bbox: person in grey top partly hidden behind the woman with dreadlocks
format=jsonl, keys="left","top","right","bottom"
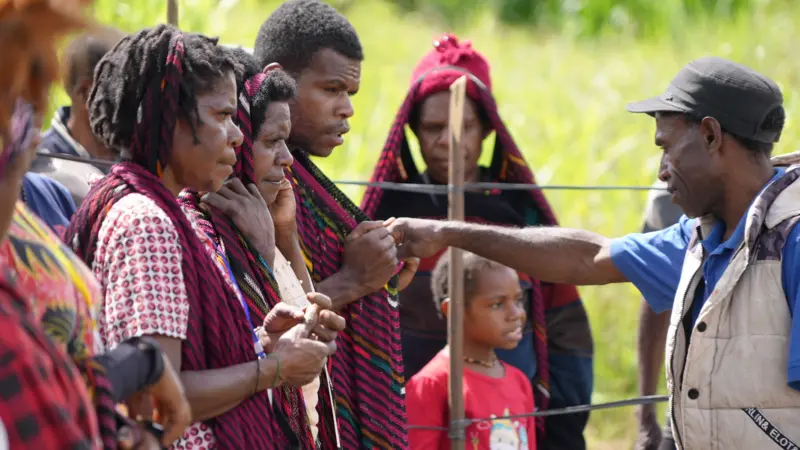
{"left": 31, "top": 26, "right": 125, "bottom": 205}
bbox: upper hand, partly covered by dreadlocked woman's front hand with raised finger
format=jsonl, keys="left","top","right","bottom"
{"left": 256, "top": 292, "right": 345, "bottom": 353}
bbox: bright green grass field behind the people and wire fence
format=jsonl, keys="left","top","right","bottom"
{"left": 58, "top": 0, "right": 800, "bottom": 450}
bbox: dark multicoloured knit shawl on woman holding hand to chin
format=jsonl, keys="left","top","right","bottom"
{"left": 180, "top": 73, "right": 336, "bottom": 450}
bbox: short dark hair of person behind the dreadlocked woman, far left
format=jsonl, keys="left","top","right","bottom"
{"left": 62, "top": 25, "right": 125, "bottom": 95}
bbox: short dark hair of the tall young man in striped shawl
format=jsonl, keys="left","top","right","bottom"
{"left": 253, "top": 0, "right": 364, "bottom": 78}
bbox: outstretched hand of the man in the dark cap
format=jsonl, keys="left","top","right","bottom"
{"left": 388, "top": 218, "right": 447, "bottom": 259}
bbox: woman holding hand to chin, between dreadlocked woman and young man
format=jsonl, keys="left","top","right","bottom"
{"left": 180, "top": 49, "right": 344, "bottom": 450}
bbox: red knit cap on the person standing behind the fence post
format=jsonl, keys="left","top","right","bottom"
{"left": 411, "top": 33, "right": 492, "bottom": 103}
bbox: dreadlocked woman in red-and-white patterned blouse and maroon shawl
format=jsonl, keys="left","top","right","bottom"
{"left": 65, "top": 25, "right": 335, "bottom": 449}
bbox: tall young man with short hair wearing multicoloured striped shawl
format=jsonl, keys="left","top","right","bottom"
{"left": 254, "top": 0, "right": 416, "bottom": 449}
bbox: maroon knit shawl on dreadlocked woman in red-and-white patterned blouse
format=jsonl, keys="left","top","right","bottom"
{"left": 65, "top": 34, "right": 286, "bottom": 450}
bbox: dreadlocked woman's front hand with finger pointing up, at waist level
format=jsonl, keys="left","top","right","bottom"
{"left": 270, "top": 304, "right": 336, "bottom": 387}
